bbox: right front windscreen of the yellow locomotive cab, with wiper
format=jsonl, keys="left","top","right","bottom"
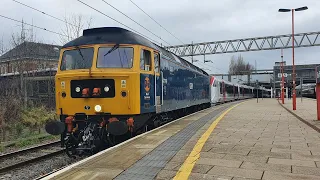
{"left": 97, "top": 46, "right": 133, "bottom": 68}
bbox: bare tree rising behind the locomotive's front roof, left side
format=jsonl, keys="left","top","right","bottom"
{"left": 60, "top": 14, "right": 92, "bottom": 44}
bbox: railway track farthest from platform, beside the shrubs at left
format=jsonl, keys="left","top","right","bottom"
{"left": 0, "top": 141, "right": 64, "bottom": 174}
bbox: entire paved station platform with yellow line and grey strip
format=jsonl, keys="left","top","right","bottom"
{"left": 45, "top": 99, "right": 320, "bottom": 180}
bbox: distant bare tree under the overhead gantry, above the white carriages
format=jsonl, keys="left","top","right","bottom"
{"left": 229, "top": 55, "right": 254, "bottom": 75}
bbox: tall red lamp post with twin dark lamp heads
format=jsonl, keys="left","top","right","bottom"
{"left": 279, "top": 6, "right": 308, "bottom": 110}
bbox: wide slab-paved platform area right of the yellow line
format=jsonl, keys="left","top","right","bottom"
{"left": 162, "top": 99, "right": 320, "bottom": 180}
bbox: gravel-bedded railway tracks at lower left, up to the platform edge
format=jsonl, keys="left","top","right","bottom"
{"left": 0, "top": 101, "right": 242, "bottom": 180}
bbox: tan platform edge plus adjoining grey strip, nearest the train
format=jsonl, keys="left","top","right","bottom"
{"left": 44, "top": 103, "right": 239, "bottom": 180}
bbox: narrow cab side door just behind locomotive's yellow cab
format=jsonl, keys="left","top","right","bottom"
{"left": 153, "top": 52, "right": 163, "bottom": 113}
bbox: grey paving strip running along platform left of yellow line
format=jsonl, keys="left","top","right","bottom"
{"left": 115, "top": 103, "right": 234, "bottom": 180}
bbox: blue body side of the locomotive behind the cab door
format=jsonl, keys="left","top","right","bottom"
{"left": 158, "top": 54, "right": 210, "bottom": 112}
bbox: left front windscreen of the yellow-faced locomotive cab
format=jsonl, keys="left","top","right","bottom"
{"left": 60, "top": 48, "right": 93, "bottom": 70}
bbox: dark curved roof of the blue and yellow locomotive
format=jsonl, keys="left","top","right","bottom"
{"left": 62, "top": 27, "right": 208, "bottom": 75}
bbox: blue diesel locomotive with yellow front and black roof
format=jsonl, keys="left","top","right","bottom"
{"left": 46, "top": 27, "right": 210, "bottom": 156}
